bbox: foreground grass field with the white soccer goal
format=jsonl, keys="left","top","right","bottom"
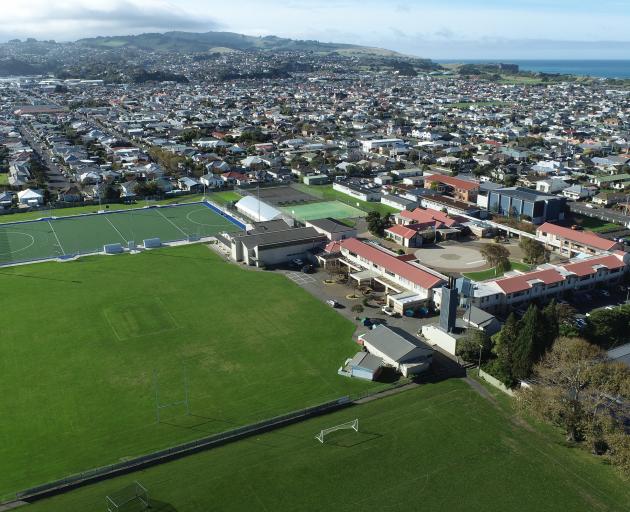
{"left": 29, "top": 380, "right": 630, "bottom": 512}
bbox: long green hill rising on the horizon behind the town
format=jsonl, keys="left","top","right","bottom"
{"left": 77, "top": 32, "right": 412, "bottom": 58}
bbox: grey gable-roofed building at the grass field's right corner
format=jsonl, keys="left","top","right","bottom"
{"left": 358, "top": 325, "right": 433, "bottom": 377}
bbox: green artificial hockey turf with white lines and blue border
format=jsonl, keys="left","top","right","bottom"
{"left": 0, "top": 203, "right": 243, "bottom": 265}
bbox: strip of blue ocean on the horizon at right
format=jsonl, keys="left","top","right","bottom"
{"left": 438, "top": 59, "right": 630, "bottom": 78}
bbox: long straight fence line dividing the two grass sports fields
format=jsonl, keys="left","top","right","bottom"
{"left": 11, "top": 379, "right": 409, "bottom": 505}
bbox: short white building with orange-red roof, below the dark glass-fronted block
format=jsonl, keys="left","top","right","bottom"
{"left": 536, "top": 222, "right": 620, "bottom": 258}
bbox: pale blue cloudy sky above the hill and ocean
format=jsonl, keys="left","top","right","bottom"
{"left": 0, "top": 0, "right": 630, "bottom": 60}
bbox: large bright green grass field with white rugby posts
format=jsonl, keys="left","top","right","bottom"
{"left": 0, "top": 245, "right": 379, "bottom": 498}
